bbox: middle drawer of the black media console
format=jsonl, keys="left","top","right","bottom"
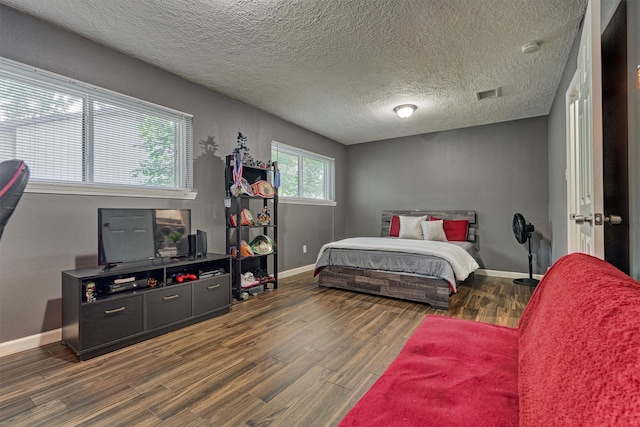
{"left": 145, "top": 284, "right": 191, "bottom": 329}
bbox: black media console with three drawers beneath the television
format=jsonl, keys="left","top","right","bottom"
{"left": 62, "top": 253, "right": 231, "bottom": 360}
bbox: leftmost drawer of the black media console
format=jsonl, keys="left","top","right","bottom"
{"left": 80, "top": 295, "right": 143, "bottom": 349}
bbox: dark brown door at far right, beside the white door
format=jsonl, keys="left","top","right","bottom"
{"left": 602, "top": 0, "right": 631, "bottom": 274}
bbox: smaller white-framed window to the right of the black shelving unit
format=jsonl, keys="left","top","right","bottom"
{"left": 271, "top": 141, "right": 334, "bottom": 203}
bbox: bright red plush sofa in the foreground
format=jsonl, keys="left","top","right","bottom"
{"left": 340, "top": 254, "right": 640, "bottom": 427}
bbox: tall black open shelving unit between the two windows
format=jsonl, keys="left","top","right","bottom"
{"left": 225, "top": 155, "right": 278, "bottom": 300}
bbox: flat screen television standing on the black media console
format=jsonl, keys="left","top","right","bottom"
{"left": 98, "top": 208, "right": 191, "bottom": 265}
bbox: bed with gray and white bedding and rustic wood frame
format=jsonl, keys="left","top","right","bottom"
{"left": 314, "top": 210, "right": 479, "bottom": 310}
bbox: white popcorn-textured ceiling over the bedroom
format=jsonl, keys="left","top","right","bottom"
{"left": 0, "top": 0, "right": 587, "bottom": 144}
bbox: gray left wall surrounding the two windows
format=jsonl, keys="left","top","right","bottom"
{"left": 0, "top": 6, "right": 346, "bottom": 342}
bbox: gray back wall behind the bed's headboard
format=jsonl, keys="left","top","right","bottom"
{"left": 347, "top": 117, "right": 550, "bottom": 273}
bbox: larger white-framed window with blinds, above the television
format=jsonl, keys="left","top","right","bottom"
{"left": 0, "top": 59, "right": 193, "bottom": 197}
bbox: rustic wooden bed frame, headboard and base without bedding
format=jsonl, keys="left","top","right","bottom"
{"left": 318, "top": 210, "right": 476, "bottom": 310}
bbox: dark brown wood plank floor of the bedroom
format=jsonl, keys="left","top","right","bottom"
{"left": 0, "top": 273, "right": 533, "bottom": 426}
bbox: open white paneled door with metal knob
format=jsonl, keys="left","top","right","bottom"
{"left": 567, "top": 0, "right": 604, "bottom": 259}
